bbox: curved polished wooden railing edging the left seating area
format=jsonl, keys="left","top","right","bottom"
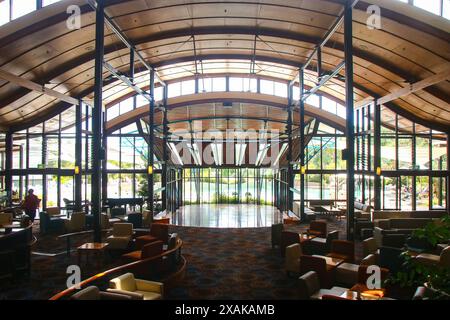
{"left": 49, "top": 239, "right": 187, "bottom": 300}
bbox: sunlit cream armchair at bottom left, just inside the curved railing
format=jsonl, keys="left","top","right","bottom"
{"left": 108, "top": 273, "right": 164, "bottom": 300}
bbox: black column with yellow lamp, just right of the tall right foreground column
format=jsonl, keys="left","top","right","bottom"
{"left": 373, "top": 100, "right": 381, "bottom": 210}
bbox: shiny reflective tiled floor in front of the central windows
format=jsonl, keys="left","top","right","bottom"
{"left": 171, "top": 204, "right": 282, "bottom": 228}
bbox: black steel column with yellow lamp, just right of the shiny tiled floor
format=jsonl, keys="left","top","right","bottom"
{"left": 299, "top": 68, "right": 306, "bottom": 221}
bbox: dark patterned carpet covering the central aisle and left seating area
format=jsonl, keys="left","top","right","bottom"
{"left": 0, "top": 220, "right": 361, "bottom": 300}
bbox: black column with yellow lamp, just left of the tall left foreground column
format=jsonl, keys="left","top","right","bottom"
{"left": 74, "top": 99, "right": 82, "bottom": 212}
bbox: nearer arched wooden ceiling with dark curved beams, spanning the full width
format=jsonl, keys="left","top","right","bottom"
{"left": 0, "top": 0, "right": 450, "bottom": 131}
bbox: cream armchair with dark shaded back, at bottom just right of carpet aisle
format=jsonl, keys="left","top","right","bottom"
{"left": 298, "top": 271, "right": 347, "bottom": 300}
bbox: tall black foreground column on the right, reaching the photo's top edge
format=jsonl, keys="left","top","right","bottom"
{"left": 344, "top": 0, "right": 355, "bottom": 240}
